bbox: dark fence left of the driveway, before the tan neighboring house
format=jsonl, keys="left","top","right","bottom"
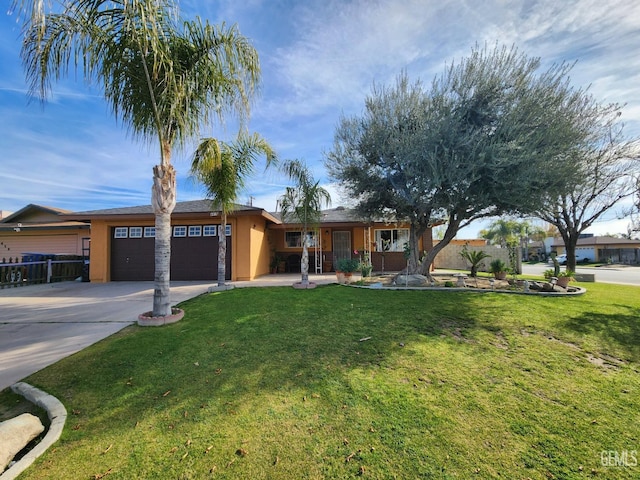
{"left": 0, "top": 255, "right": 88, "bottom": 288}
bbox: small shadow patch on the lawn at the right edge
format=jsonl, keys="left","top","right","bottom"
{"left": 561, "top": 305, "right": 640, "bottom": 362}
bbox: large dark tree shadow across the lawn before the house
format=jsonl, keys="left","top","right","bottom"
{"left": 26, "top": 286, "right": 484, "bottom": 432}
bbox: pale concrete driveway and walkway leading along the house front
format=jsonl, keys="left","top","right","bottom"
{"left": 0, "top": 274, "right": 335, "bottom": 390}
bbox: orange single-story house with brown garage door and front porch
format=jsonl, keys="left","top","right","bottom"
{"left": 66, "top": 200, "right": 432, "bottom": 282}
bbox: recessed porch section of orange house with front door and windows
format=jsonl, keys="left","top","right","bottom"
{"left": 270, "top": 207, "right": 433, "bottom": 273}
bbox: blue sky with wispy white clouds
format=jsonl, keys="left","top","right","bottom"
{"left": 0, "top": 0, "right": 640, "bottom": 238}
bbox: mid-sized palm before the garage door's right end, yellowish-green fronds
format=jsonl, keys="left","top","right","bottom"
{"left": 191, "top": 131, "right": 276, "bottom": 287}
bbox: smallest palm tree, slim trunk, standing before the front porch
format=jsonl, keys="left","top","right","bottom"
{"left": 279, "top": 160, "right": 331, "bottom": 287}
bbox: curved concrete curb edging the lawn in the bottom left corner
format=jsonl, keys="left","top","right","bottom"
{"left": 0, "top": 382, "right": 67, "bottom": 480}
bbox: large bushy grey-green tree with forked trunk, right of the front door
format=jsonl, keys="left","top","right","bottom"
{"left": 325, "top": 46, "right": 593, "bottom": 274}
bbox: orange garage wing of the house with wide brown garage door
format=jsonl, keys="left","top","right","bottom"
{"left": 67, "top": 200, "right": 279, "bottom": 282}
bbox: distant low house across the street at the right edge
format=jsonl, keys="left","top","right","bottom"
{"left": 552, "top": 236, "right": 640, "bottom": 264}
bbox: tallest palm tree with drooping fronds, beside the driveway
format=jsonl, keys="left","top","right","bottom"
{"left": 21, "top": 0, "right": 260, "bottom": 316}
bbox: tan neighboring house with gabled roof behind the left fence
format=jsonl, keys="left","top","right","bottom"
{"left": 0, "top": 204, "right": 90, "bottom": 261}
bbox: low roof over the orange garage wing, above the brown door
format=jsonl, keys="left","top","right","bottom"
{"left": 65, "top": 199, "right": 280, "bottom": 223}
